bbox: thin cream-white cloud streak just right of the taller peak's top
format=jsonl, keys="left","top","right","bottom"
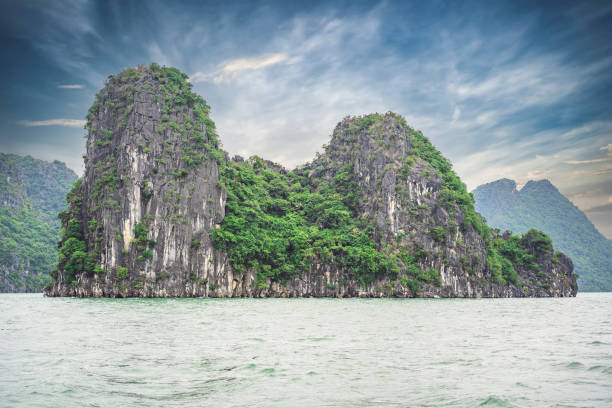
{"left": 190, "top": 52, "right": 292, "bottom": 83}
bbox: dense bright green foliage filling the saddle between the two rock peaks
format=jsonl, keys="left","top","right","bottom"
{"left": 212, "top": 157, "right": 397, "bottom": 286}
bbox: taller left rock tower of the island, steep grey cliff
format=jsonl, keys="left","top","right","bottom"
{"left": 47, "top": 64, "right": 231, "bottom": 296}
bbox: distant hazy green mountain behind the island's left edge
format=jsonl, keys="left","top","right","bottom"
{"left": 0, "top": 153, "right": 77, "bottom": 292}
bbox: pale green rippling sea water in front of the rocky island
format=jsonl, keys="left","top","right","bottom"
{"left": 0, "top": 293, "right": 612, "bottom": 407}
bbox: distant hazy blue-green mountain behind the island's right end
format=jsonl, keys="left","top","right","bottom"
{"left": 472, "top": 179, "right": 612, "bottom": 291}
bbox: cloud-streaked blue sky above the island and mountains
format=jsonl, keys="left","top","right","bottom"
{"left": 0, "top": 0, "right": 612, "bottom": 237}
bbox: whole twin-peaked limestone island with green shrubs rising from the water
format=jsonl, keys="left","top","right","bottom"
{"left": 46, "top": 65, "right": 577, "bottom": 297}
